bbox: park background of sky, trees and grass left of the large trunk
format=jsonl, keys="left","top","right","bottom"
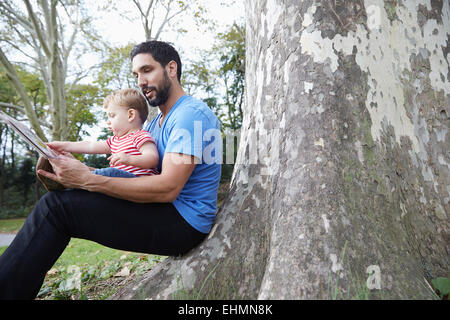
{"left": 0, "top": 0, "right": 245, "bottom": 299}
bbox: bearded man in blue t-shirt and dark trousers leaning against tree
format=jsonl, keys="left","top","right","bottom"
{"left": 0, "top": 41, "right": 221, "bottom": 299}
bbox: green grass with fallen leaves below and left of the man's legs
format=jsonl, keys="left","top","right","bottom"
{"left": 0, "top": 219, "right": 165, "bottom": 300}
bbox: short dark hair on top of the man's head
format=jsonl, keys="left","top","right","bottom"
{"left": 130, "top": 40, "right": 181, "bottom": 83}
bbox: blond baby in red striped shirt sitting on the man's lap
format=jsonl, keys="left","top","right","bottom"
{"left": 47, "top": 89, "right": 159, "bottom": 178}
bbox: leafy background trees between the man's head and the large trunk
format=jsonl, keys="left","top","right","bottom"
{"left": 182, "top": 23, "right": 245, "bottom": 182}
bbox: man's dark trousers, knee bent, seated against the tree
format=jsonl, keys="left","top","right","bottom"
{"left": 0, "top": 189, "right": 206, "bottom": 299}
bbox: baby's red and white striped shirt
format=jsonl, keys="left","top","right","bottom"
{"left": 106, "top": 129, "right": 158, "bottom": 176}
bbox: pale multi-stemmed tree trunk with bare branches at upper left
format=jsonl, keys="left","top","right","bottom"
{"left": 0, "top": 0, "right": 79, "bottom": 141}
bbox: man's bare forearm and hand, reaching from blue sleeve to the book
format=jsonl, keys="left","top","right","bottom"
{"left": 39, "top": 152, "right": 195, "bottom": 203}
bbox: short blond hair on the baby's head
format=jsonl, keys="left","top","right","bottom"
{"left": 103, "top": 89, "right": 148, "bottom": 123}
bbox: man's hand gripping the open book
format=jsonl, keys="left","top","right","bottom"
{"left": 38, "top": 152, "right": 92, "bottom": 188}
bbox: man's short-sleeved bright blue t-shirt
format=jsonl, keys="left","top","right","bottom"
{"left": 145, "top": 95, "right": 222, "bottom": 233}
